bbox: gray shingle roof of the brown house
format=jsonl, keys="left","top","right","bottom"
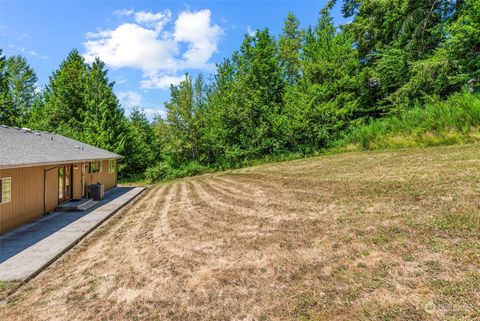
{"left": 0, "top": 125, "right": 122, "bottom": 169}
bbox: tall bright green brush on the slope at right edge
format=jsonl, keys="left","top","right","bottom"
{"left": 337, "top": 91, "right": 480, "bottom": 149}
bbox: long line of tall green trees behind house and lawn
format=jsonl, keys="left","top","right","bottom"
{"left": 0, "top": 0, "right": 480, "bottom": 179}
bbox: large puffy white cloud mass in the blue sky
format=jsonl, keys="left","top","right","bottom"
{"left": 84, "top": 9, "right": 223, "bottom": 89}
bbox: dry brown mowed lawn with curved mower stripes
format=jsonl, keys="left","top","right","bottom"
{"left": 0, "top": 145, "right": 480, "bottom": 321}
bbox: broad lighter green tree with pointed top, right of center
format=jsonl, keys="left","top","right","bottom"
{"left": 285, "top": 10, "right": 363, "bottom": 152}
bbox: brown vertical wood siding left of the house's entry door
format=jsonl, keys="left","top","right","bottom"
{"left": 0, "top": 166, "right": 58, "bottom": 233}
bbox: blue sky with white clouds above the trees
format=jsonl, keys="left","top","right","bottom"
{"left": 0, "top": 1, "right": 346, "bottom": 117}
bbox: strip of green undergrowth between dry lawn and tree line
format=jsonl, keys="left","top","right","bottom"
{"left": 138, "top": 91, "right": 480, "bottom": 184}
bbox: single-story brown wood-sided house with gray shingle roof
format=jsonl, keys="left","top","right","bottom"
{"left": 0, "top": 125, "right": 122, "bottom": 233}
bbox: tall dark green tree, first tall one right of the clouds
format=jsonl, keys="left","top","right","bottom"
{"left": 228, "top": 29, "right": 285, "bottom": 157}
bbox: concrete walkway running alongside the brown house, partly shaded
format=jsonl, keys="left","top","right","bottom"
{"left": 0, "top": 187, "right": 144, "bottom": 281}
